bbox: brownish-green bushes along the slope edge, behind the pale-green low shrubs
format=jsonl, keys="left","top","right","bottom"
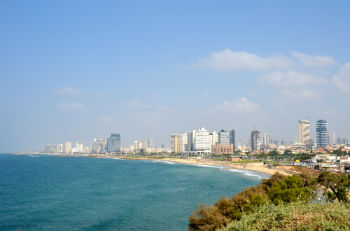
{"left": 188, "top": 174, "right": 312, "bottom": 231}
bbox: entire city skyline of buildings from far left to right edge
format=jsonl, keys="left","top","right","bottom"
{"left": 44, "top": 120, "right": 348, "bottom": 156}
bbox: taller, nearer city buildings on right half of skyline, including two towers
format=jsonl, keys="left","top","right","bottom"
{"left": 170, "top": 120, "right": 348, "bottom": 155}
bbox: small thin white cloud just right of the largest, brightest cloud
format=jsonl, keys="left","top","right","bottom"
{"left": 292, "top": 51, "right": 337, "bottom": 68}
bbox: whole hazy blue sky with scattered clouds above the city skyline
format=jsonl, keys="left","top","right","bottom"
{"left": 0, "top": 0, "right": 350, "bottom": 152}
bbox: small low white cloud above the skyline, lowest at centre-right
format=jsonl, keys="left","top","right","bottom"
{"left": 216, "top": 97, "right": 262, "bottom": 114}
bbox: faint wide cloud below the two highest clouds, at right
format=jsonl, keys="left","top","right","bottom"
{"left": 259, "top": 70, "right": 327, "bottom": 88}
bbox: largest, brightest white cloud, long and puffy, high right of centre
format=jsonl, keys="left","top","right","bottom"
{"left": 193, "top": 49, "right": 293, "bottom": 71}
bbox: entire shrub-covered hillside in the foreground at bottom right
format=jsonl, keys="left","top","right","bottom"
{"left": 188, "top": 172, "right": 350, "bottom": 231}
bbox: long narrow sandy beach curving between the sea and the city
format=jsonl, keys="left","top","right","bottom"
{"left": 12, "top": 153, "right": 293, "bottom": 176}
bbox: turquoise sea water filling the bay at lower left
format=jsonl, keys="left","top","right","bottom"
{"left": 0, "top": 154, "right": 261, "bottom": 230}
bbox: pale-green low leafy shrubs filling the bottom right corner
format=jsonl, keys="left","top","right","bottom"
{"left": 220, "top": 202, "right": 350, "bottom": 231}
